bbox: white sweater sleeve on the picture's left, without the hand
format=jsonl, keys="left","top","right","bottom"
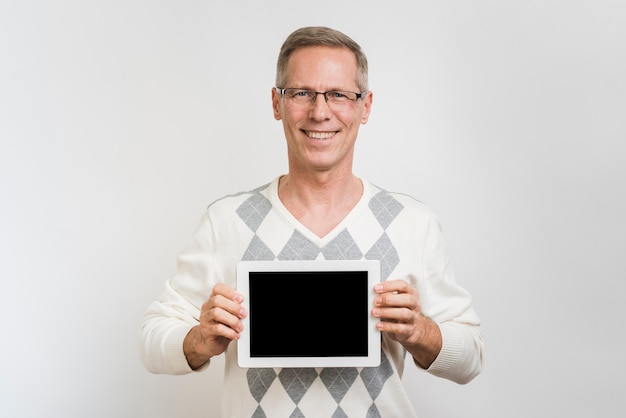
{"left": 140, "top": 214, "right": 215, "bottom": 374}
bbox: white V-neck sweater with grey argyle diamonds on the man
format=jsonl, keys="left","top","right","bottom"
{"left": 141, "top": 178, "right": 483, "bottom": 418}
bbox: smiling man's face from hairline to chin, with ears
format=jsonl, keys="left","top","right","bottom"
{"left": 272, "top": 46, "right": 372, "bottom": 172}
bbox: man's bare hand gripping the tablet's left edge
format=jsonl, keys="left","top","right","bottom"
{"left": 183, "top": 283, "right": 247, "bottom": 369}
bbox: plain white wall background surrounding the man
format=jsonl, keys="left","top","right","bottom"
{"left": 0, "top": 0, "right": 626, "bottom": 417}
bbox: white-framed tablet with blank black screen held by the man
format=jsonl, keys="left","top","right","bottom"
{"left": 237, "top": 260, "right": 381, "bottom": 368}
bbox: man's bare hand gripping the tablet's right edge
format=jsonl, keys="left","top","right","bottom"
{"left": 372, "top": 280, "right": 442, "bottom": 369}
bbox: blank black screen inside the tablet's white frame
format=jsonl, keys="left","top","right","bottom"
{"left": 249, "top": 271, "right": 371, "bottom": 357}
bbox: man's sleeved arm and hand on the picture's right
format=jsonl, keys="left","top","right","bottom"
{"left": 372, "top": 214, "right": 483, "bottom": 383}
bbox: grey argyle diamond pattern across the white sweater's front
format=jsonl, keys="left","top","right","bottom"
{"left": 237, "top": 187, "right": 404, "bottom": 418}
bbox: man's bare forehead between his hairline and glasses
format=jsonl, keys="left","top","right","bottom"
{"left": 287, "top": 46, "right": 358, "bottom": 90}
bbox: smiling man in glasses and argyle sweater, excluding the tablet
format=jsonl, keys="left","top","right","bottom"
{"left": 142, "top": 27, "right": 483, "bottom": 418}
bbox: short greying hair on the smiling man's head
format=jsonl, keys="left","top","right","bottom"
{"left": 276, "top": 26, "right": 368, "bottom": 92}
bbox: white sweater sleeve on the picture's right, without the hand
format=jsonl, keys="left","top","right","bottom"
{"left": 418, "top": 213, "right": 483, "bottom": 384}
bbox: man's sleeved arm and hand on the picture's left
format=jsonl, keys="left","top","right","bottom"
{"left": 140, "top": 212, "right": 246, "bottom": 374}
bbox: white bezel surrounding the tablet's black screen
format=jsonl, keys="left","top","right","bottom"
{"left": 237, "top": 260, "right": 381, "bottom": 368}
